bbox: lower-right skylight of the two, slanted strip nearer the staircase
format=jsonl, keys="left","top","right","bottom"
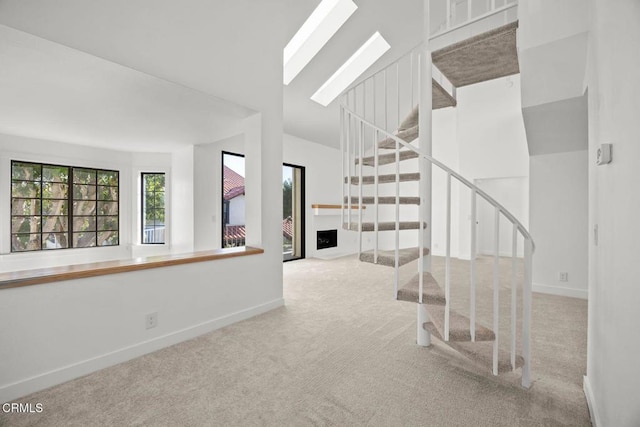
{"left": 311, "top": 31, "right": 391, "bottom": 107}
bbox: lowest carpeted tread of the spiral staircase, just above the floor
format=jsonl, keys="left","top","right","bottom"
{"left": 425, "top": 323, "right": 524, "bottom": 374}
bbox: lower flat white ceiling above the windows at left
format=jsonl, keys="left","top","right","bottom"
{"left": 0, "top": 25, "right": 250, "bottom": 152}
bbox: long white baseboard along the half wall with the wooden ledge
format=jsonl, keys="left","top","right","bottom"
{"left": 0, "top": 298, "right": 284, "bottom": 402}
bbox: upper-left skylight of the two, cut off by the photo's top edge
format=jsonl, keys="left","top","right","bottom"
{"left": 283, "top": 0, "right": 358, "bottom": 85}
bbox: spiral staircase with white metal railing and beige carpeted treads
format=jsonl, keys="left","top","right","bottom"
{"left": 340, "top": 19, "right": 534, "bottom": 387}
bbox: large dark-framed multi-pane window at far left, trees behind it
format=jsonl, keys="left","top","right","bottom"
{"left": 11, "top": 161, "right": 119, "bottom": 252}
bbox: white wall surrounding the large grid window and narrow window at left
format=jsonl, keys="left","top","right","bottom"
{"left": 0, "top": 134, "right": 193, "bottom": 271}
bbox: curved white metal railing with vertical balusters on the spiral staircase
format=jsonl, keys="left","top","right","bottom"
{"left": 340, "top": 42, "right": 535, "bottom": 387}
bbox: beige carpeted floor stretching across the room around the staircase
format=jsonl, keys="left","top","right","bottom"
{"left": 0, "top": 256, "right": 590, "bottom": 427}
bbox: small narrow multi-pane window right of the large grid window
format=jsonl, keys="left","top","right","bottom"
{"left": 142, "top": 173, "right": 165, "bottom": 244}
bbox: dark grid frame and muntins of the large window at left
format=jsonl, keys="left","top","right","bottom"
{"left": 9, "top": 159, "right": 121, "bottom": 254}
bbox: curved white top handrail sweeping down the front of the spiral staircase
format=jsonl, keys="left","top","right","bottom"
{"left": 340, "top": 106, "right": 536, "bottom": 253}
